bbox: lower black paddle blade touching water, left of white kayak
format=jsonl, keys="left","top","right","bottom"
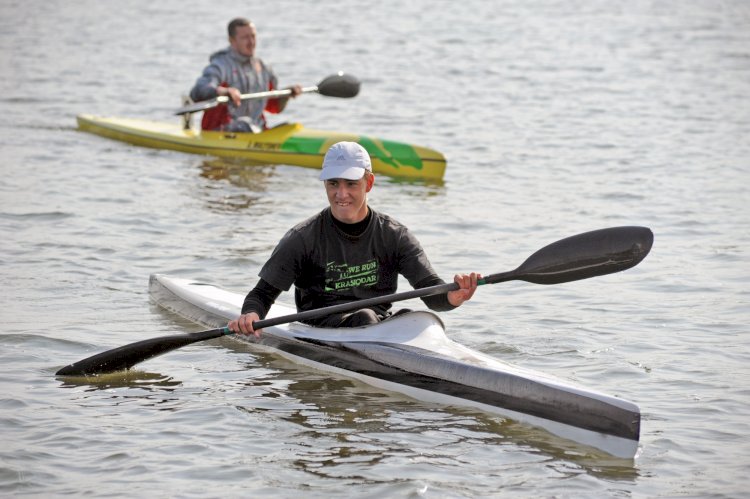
{"left": 55, "top": 328, "right": 229, "bottom": 376}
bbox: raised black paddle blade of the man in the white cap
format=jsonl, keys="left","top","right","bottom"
{"left": 485, "top": 227, "right": 654, "bottom": 284}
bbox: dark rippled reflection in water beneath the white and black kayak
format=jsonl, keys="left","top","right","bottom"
{"left": 231, "top": 356, "right": 639, "bottom": 481}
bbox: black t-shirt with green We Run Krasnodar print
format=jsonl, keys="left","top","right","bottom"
{"left": 259, "top": 208, "right": 444, "bottom": 314}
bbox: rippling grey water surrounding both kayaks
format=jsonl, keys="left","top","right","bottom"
{"left": 0, "top": 0, "right": 750, "bottom": 498}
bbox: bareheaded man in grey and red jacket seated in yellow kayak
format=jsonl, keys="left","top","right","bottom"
{"left": 190, "top": 18, "right": 302, "bottom": 132}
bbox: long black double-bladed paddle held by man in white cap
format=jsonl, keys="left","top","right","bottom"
{"left": 56, "top": 227, "right": 654, "bottom": 376}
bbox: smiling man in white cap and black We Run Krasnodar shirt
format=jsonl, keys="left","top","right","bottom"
{"left": 229, "top": 142, "right": 481, "bottom": 336}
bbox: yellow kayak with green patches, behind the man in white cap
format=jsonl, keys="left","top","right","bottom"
{"left": 77, "top": 114, "right": 446, "bottom": 180}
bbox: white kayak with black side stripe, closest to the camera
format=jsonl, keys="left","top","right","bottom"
{"left": 149, "top": 274, "right": 640, "bottom": 459}
